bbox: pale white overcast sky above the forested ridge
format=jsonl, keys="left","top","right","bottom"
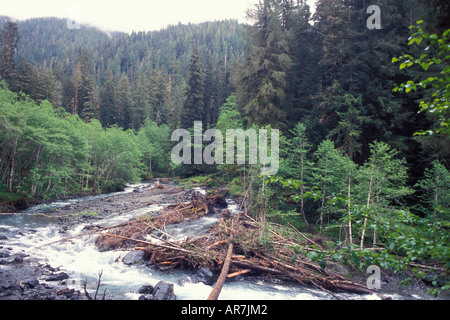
{"left": 0, "top": 0, "right": 314, "bottom": 32}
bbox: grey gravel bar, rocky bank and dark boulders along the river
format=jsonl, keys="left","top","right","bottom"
{"left": 0, "top": 181, "right": 442, "bottom": 300}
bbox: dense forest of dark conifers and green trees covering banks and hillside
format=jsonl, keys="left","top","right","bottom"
{"left": 0, "top": 0, "right": 450, "bottom": 292}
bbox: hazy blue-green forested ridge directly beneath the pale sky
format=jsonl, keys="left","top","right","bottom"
{"left": 0, "top": 16, "right": 245, "bottom": 78}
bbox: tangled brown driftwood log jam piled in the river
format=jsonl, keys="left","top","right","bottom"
{"left": 96, "top": 194, "right": 384, "bottom": 299}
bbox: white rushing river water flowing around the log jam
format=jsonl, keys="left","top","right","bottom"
{"left": 0, "top": 185, "right": 408, "bottom": 300}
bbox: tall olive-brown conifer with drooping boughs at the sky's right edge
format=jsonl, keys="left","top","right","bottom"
{"left": 235, "top": 0, "right": 292, "bottom": 127}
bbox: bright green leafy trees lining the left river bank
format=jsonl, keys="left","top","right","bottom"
{"left": 0, "top": 83, "right": 142, "bottom": 199}
